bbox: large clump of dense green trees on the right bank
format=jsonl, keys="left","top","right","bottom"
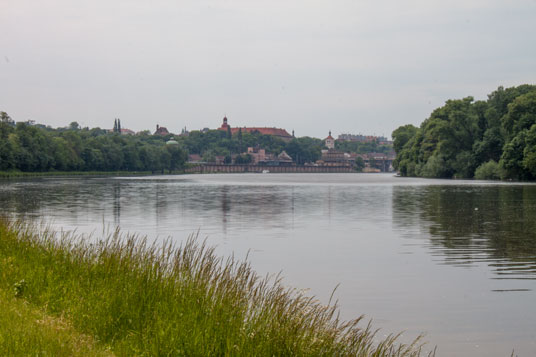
{"left": 392, "top": 84, "right": 536, "bottom": 180}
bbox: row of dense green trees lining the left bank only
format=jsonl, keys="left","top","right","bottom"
{"left": 0, "top": 113, "right": 186, "bottom": 172}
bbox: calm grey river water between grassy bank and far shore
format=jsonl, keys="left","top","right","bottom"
{"left": 0, "top": 174, "right": 536, "bottom": 356}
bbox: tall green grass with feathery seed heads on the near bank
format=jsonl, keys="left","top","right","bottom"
{"left": 0, "top": 221, "right": 430, "bottom": 356}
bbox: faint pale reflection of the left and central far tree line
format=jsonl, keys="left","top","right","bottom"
{"left": 0, "top": 178, "right": 382, "bottom": 236}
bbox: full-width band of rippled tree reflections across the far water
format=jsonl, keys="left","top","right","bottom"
{"left": 4, "top": 176, "right": 536, "bottom": 279}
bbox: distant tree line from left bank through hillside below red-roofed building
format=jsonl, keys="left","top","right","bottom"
{"left": 0, "top": 112, "right": 391, "bottom": 172}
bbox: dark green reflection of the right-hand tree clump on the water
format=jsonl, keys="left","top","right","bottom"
{"left": 393, "top": 185, "right": 536, "bottom": 279}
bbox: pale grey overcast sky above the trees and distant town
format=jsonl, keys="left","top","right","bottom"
{"left": 0, "top": 0, "right": 536, "bottom": 137}
